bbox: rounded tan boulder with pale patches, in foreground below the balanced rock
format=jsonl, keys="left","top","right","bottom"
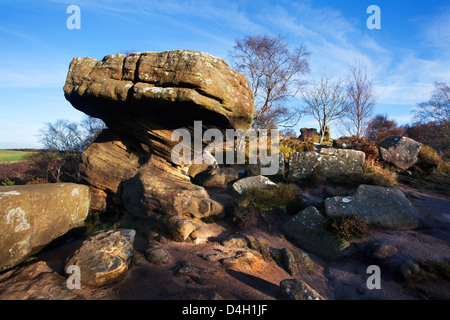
{"left": 65, "top": 229, "right": 136, "bottom": 287}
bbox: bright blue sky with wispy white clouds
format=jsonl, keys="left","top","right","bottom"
{"left": 0, "top": 0, "right": 450, "bottom": 148}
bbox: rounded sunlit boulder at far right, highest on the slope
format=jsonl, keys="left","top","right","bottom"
{"left": 378, "top": 136, "right": 422, "bottom": 170}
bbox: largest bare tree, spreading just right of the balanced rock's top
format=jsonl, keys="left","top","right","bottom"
{"left": 230, "top": 35, "right": 309, "bottom": 128}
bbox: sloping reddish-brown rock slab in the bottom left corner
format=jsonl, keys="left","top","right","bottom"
{"left": 0, "top": 261, "right": 77, "bottom": 300}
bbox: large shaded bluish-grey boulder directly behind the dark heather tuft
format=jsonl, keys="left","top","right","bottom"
{"left": 325, "top": 185, "right": 420, "bottom": 230}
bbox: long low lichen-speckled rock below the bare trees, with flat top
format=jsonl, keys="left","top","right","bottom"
{"left": 287, "top": 148, "right": 365, "bottom": 181}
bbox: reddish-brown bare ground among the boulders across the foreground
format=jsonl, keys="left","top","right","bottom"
{"left": 0, "top": 178, "right": 450, "bottom": 300}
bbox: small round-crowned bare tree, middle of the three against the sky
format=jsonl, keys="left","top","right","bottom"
{"left": 303, "top": 74, "right": 350, "bottom": 143}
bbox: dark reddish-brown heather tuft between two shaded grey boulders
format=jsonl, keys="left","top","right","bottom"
{"left": 322, "top": 215, "right": 368, "bottom": 241}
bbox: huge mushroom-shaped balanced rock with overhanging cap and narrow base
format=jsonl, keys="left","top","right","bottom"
{"left": 64, "top": 50, "right": 254, "bottom": 239}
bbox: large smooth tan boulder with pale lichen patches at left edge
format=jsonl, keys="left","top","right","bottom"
{"left": 0, "top": 183, "right": 90, "bottom": 271}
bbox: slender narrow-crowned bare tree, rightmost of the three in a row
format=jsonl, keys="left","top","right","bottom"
{"left": 342, "top": 61, "right": 378, "bottom": 139}
